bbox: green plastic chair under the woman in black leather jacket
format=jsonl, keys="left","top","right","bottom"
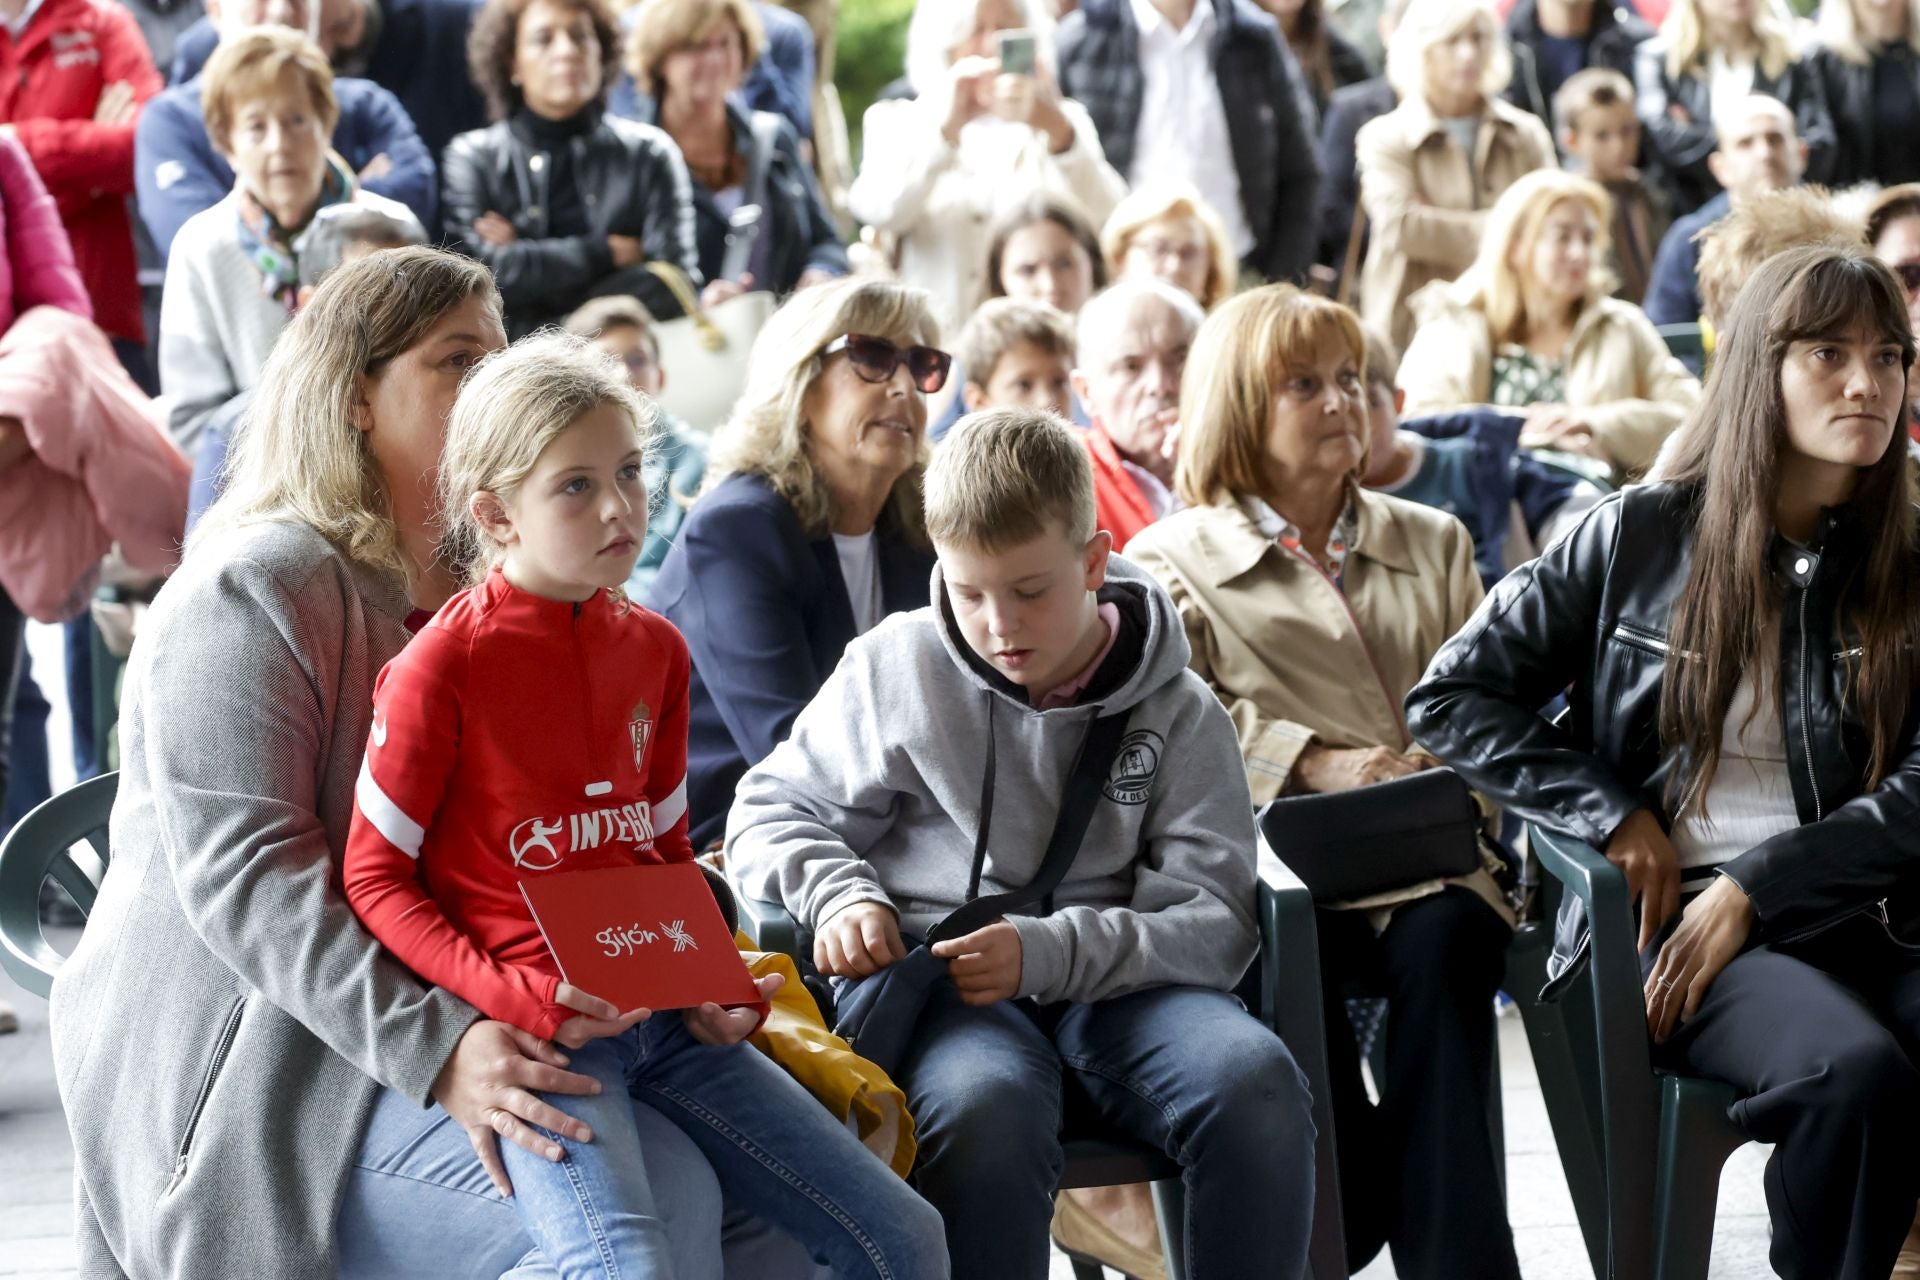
{"left": 1517, "top": 825, "right": 1747, "bottom": 1280}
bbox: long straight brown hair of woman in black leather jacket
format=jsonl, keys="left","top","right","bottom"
{"left": 1661, "top": 246, "right": 1920, "bottom": 816}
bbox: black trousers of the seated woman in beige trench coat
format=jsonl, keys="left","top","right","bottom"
{"left": 1315, "top": 887, "right": 1520, "bottom": 1280}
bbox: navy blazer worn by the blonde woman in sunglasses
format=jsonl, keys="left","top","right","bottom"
{"left": 653, "top": 474, "right": 933, "bottom": 850}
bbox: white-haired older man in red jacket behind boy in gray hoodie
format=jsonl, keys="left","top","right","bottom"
{"left": 1073, "top": 280, "right": 1206, "bottom": 551}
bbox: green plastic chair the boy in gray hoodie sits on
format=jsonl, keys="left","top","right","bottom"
{"left": 739, "top": 858, "right": 1346, "bottom": 1280}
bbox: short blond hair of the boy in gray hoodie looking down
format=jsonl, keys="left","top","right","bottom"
{"left": 925, "top": 409, "right": 1096, "bottom": 555}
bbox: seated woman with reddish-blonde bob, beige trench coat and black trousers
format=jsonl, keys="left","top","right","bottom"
{"left": 1127, "top": 284, "right": 1519, "bottom": 1280}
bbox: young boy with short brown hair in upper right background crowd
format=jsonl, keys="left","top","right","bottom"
{"left": 1553, "top": 67, "right": 1670, "bottom": 305}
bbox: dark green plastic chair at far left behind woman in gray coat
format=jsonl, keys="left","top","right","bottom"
{"left": 0, "top": 773, "right": 119, "bottom": 998}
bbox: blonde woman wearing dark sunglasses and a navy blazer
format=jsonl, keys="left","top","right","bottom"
{"left": 653, "top": 278, "right": 952, "bottom": 848}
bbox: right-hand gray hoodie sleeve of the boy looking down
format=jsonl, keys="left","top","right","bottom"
{"left": 1012, "top": 687, "right": 1260, "bottom": 1004}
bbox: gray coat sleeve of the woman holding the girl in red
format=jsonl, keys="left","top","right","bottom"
{"left": 142, "top": 560, "right": 478, "bottom": 1105}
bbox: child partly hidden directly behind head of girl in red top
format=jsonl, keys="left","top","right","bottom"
{"left": 566, "top": 296, "right": 707, "bottom": 604}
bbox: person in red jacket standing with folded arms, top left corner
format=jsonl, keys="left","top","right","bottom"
{"left": 0, "top": 0, "right": 161, "bottom": 383}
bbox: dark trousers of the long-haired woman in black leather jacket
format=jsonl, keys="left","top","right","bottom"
{"left": 1642, "top": 917, "right": 1920, "bottom": 1280}
